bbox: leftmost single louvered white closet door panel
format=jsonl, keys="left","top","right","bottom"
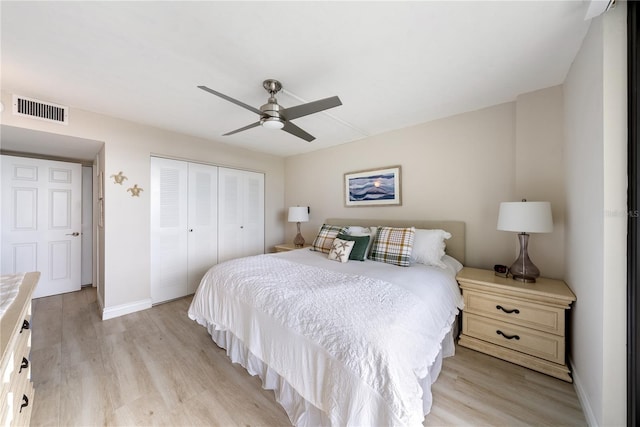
{"left": 150, "top": 157, "right": 189, "bottom": 304}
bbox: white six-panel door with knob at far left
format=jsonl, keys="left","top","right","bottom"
{"left": 1, "top": 156, "right": 82, "bottom": 298}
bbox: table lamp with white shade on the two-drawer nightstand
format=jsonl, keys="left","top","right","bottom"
{"left": 497, "top": 199, "right": 553, "bottom": 283}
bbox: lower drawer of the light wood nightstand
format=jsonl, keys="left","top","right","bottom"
{"left": 462, "top": 312, "right": 565, "bottom": 364}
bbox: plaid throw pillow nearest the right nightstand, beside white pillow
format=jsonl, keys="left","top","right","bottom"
{"left": 369, "top": 227, "right": 416, "bottom": 267}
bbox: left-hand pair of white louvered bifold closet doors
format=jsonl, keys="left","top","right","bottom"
{"left": 151, "top": 157, "right": 218, "bottom": 304}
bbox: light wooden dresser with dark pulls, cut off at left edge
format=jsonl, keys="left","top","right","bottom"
{"left": 0, "top": 272, "right": 40, "bottom": 426}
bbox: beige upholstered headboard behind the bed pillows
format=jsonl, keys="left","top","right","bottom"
{"left": 325, "top": 218, "right": 465, "bottom": 264}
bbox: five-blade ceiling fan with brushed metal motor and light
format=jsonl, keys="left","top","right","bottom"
{"left": 198, "top": 79, "right": 342, "bottom": 142}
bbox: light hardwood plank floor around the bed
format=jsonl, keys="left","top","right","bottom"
{"left": 31, "top": 288, "right": 586, "bottom": 426}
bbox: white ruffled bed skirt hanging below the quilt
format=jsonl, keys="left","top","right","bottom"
{"left": 207, "top": 322, "right": 457, "bottom": 426}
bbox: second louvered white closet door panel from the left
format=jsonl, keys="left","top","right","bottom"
{"left": 187, "top": 163, "right": 218, "bottom": 294}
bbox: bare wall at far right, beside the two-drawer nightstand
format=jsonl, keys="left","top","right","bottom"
{"left": 564, "top": 2, "right": 627, "bottom": 426}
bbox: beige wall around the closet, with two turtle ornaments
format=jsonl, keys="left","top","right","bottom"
{"left": 2, "top": 92, "right": 284, "bottom": 317}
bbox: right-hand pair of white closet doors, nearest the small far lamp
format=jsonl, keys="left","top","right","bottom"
{"left": 218, "top": 168, "right": 264, "bottom": 262}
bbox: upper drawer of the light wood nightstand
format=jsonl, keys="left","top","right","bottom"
{"left": 464, "top": 290, "right": 565, "bottom": 336}
